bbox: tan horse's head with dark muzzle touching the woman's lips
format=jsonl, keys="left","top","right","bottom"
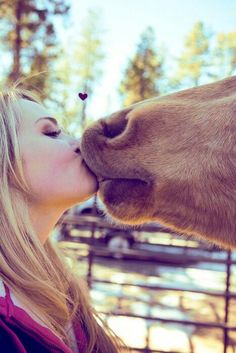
{"left": 81, "top": 76, "right": 236, "bottom": 248}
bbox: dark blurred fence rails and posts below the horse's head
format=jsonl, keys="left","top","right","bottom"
{"left": 58, "top": 215, "right": 236, "bottom": 353}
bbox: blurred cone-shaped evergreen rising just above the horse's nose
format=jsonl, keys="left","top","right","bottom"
{"left": 119, "top": 27, "right": 164, "bottom": 106}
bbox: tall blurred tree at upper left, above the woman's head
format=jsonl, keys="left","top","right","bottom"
{"left": 0, "top": 0, "right": 69, "bottom": 98}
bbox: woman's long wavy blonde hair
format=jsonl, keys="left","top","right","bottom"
{"left": 0, "top": 84, "right": 127, "bottom": 353}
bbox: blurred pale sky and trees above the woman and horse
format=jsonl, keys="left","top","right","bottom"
{"left": 0, "top": 0, "right": 236, "bottom": 135}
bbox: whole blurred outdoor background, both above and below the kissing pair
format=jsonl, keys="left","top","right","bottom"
{"left": 0, "top": 0, "right": 236, "bottom": 353}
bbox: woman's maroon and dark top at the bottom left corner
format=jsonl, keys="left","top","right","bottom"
{"left": 0, "top": 282, "right": 86, "bottom": 353}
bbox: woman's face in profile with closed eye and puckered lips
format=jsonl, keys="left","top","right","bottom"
{"left": 16, "top": 99, "right": 98, "bottom": 210}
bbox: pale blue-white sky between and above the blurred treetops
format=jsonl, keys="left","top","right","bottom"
{"left": 55, "top": 0, "right": 236, "bottom": 119}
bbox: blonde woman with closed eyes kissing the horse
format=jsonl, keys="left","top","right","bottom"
{"left": 0, "top": 85, "right": 125, "bottom": 353}
